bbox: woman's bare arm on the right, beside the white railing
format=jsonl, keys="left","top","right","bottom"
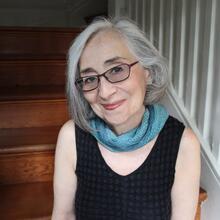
{"left": 171, "top": 129, "right": 200, "bottom": 220}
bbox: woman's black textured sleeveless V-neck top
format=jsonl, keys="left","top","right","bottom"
{"left": 75, "top": 116, "right": 184, "bottom": 220}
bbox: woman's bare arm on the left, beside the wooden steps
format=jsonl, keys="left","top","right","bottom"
{"left": 52, "top": 121, "right": 77, "bottom": 220}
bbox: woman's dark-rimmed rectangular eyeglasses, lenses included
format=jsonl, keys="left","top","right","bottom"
{"left": 75, "top": 61, "right": 138, "bottom": 92}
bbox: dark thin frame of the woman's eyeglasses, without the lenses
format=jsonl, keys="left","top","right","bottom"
{"left": 75, "top": 61, "right": 139, "bottom": 92}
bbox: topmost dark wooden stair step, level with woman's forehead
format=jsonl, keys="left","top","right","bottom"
{"left": 0, "top": 27, "right": 81, "bottom": 60}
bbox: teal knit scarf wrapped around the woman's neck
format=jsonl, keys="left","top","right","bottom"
{"left": 90, "top": 104, "right": 168, "bottom": 152}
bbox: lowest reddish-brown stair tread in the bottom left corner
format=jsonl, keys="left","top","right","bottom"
{"left": 0, "top": 182, "right": 53, "bottom": 220}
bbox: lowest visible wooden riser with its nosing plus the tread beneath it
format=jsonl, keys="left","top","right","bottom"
{"left": 0, "top": 144, "right": 55, "bottom": 220}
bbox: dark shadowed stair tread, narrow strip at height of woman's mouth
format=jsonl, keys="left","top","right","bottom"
{"left": 0, "top": 85, "right": 65, "bottom": 101}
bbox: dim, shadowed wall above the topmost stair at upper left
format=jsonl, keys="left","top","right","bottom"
{"left": 0, "top": 0, "right": 108, "bottom": 27}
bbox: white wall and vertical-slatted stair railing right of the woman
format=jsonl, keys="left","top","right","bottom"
{"left": 109, "top": 0, "right": 220, "bottom": 220}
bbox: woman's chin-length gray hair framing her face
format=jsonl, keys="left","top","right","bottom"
{"left": 66, "top": 18, "right": 168, "bottom": 131}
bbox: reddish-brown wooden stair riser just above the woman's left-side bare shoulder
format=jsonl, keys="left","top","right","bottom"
{"left": 0, "top": 99, "right": 68, "bottom": 129}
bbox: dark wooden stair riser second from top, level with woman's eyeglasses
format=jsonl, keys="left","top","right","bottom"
{"left": 0, "top": 59, "right": 66, "bottom": 87}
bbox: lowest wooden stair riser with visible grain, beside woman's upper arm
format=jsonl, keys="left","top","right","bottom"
{"left": 0, "top": 150, "right": 54, "bottom": 185}
